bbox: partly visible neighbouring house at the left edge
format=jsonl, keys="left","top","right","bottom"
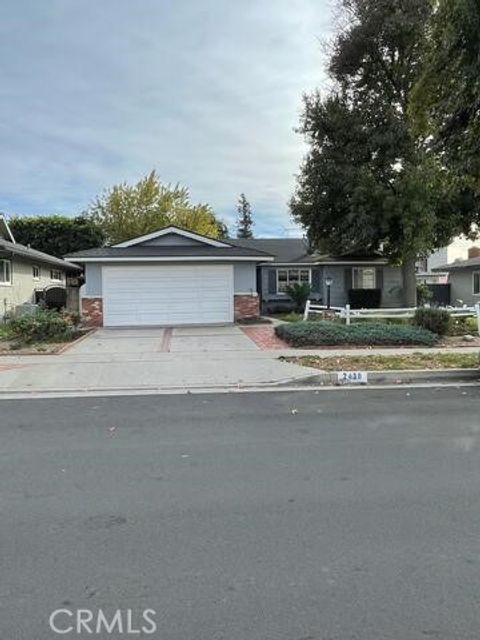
{"left": 0, "top": 216, "right": 82, "bottom": 319}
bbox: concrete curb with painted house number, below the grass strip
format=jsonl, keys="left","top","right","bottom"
{"left": 281, "top": 368, "right": 480, "bottom": 387}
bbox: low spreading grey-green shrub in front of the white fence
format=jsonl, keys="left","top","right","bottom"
{"left": 275, "top": 322, "right": 437, "bottom": 347}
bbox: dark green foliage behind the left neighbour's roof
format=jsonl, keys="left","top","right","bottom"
{"left": 9, "top": 216, "right": 104, "bottom": 258}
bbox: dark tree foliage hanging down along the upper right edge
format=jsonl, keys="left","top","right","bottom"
{"left": 410, "top": 0, "right": 480, "bottom": 233}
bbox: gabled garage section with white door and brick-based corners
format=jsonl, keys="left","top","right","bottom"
{"left": 67, "top": 226, "right": 273, "bottom": 327}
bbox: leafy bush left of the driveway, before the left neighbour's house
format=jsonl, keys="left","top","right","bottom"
{"left": 7, "top": 308, "right": 76, "bottom": 344}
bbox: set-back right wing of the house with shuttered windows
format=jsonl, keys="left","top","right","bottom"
{"left": 235, "top": 238, "right": 403, "bottom": 313}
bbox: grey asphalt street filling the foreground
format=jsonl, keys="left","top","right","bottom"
{"left": 0, "top": 387, "right": 480, "bottom": 640}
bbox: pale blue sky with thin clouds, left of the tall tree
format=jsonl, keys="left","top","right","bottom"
{"left": 0, "top": 0, "right": 331, "bottom": 236}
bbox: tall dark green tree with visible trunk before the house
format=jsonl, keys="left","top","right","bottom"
{"left": 291, "top": 0, "right": 456, "bottom": 304}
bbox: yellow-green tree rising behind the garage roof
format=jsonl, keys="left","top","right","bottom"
{"left": 85, "top": 171, "right": 225, "bottom": 243}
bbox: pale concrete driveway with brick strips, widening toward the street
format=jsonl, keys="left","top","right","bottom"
{"left": 0, "top": 326, "right": 317, "bottom": 397}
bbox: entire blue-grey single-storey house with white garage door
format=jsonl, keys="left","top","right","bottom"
{"left": 67, "top": 226, "right": 401, "bottom": 327}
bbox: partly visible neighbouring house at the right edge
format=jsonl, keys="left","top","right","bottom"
{"left": 433, "top": 247, "right": 480, "bottom": 306}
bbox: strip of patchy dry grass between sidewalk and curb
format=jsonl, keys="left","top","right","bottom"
{"left": 280, "top": 353, "right": 479, "bottom": 371}
